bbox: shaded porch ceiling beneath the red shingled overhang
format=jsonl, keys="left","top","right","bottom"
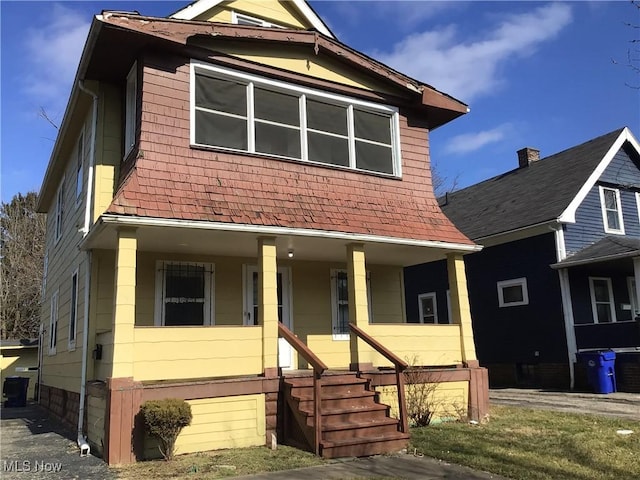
{"left": 81, "top": 218, "right": 468, "bottom": 266}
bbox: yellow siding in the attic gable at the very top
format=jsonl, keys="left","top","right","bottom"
{"left": 196, "top": 0, "right": 312, "bottom": 30}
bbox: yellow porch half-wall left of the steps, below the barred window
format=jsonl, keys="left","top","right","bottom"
{"left": 133, "top": 327, "right": 262, "bottom": 381}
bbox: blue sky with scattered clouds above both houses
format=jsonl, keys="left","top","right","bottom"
{"left": 0, "top": 0, "right": 640, "bottom": 202}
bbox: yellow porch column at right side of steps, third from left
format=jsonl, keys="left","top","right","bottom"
{"left": 347, "top": 243, "right": 369, "bottom": 370}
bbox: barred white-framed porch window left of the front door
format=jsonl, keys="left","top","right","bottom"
{"left": 156, "top": 262, "right": 214, "bottom": 326}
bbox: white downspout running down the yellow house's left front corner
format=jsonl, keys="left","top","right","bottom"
{"left": 77, "top": 80, "right": 98, "bottom": 456}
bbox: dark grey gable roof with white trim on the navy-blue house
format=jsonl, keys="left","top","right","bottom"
{"left": 439, "top": 127, "right": 640, "bottom": 240}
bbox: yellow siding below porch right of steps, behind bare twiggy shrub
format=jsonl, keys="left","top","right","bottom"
{"left": 375, "top": 380, "right": 469, "bottom": 421}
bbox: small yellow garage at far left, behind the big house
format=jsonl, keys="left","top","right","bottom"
{"left": 0, "top": 339, "right": 38, "bottom": 400}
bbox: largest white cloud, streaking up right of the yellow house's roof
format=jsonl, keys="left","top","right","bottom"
{"left": 373, "top": 3, "right": 571, "bottom": 101}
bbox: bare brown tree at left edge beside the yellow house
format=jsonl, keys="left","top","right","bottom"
{"left": 0, "top": 192, "right": 46, "bottom": 339}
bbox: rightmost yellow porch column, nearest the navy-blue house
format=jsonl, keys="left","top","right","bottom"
{"left": 447, "top": 253, "right": 479, "bottom": 368}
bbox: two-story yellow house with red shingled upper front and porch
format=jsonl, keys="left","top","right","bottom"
{"left": 39, "top": 0, "right": 487, "bottom": 463}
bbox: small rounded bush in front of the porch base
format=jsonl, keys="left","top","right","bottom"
{"left": 140, "top": 398, "right": 193, "bottom": 460}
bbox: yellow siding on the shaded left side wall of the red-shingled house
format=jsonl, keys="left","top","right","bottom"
{"left": 41, "top": 108, "right": 91, "bottom": 392}
